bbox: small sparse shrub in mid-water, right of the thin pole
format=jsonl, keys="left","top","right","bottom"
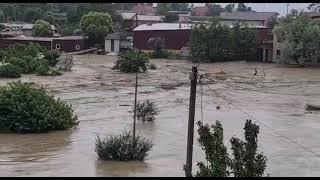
{"left": 136, "top": 100, "right": 159, "bottom": 121}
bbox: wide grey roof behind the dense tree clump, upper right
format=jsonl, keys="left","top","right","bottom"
{"left": 217, "top": 11, "right": 279, "bottom": 21}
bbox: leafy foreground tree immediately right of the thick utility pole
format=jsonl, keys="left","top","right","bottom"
{"left": 196, "top": 121, "right": 231, "bottom": 177}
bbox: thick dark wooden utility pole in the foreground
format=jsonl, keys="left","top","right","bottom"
{"left": 184, "top": 66, "right": 198, "bottom": 177}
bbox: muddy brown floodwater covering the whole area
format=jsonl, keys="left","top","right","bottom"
{"left": 0, "top": 55, "right": 320, "bottom": 176}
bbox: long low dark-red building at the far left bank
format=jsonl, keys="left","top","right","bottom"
{"left": 0, "top": 36, "right": 88, "bottom": 52}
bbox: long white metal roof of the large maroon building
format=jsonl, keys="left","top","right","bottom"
{"left": 133, "top": 23, "right": 192, "bottom": 31}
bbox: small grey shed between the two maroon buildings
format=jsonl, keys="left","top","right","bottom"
{"left": 104, "top": 32, "right": 133, "bottom": 53}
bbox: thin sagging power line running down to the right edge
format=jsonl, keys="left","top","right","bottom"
{"left": 202, "top": 85, "right": 320, "bottom": 157}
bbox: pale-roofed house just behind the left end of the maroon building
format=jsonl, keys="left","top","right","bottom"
{"left": 120, "top": 12, "right": 164, "bottom": 32}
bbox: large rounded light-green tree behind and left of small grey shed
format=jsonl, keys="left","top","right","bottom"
{"left": 80, "top": 12, "right": 114, "bottom": 44}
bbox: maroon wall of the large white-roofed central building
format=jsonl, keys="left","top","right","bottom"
{"left": 133, "top": 30, "right": 190, "bottom": 50}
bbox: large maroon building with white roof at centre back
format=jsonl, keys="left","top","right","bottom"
{"left": 133, "top": 23, "right": 191, "bottom": 52}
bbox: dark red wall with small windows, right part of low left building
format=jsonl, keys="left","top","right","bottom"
{"left": 52, "top": 39, "right": 88, "bottom": 53}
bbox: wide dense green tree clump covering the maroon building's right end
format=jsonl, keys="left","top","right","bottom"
{"left": 191, "top": 19, "right": 257, "bottom": 62}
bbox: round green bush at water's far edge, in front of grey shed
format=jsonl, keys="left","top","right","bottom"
{"left": 114, "top": 50, "right": 149, "bottom": 73}
